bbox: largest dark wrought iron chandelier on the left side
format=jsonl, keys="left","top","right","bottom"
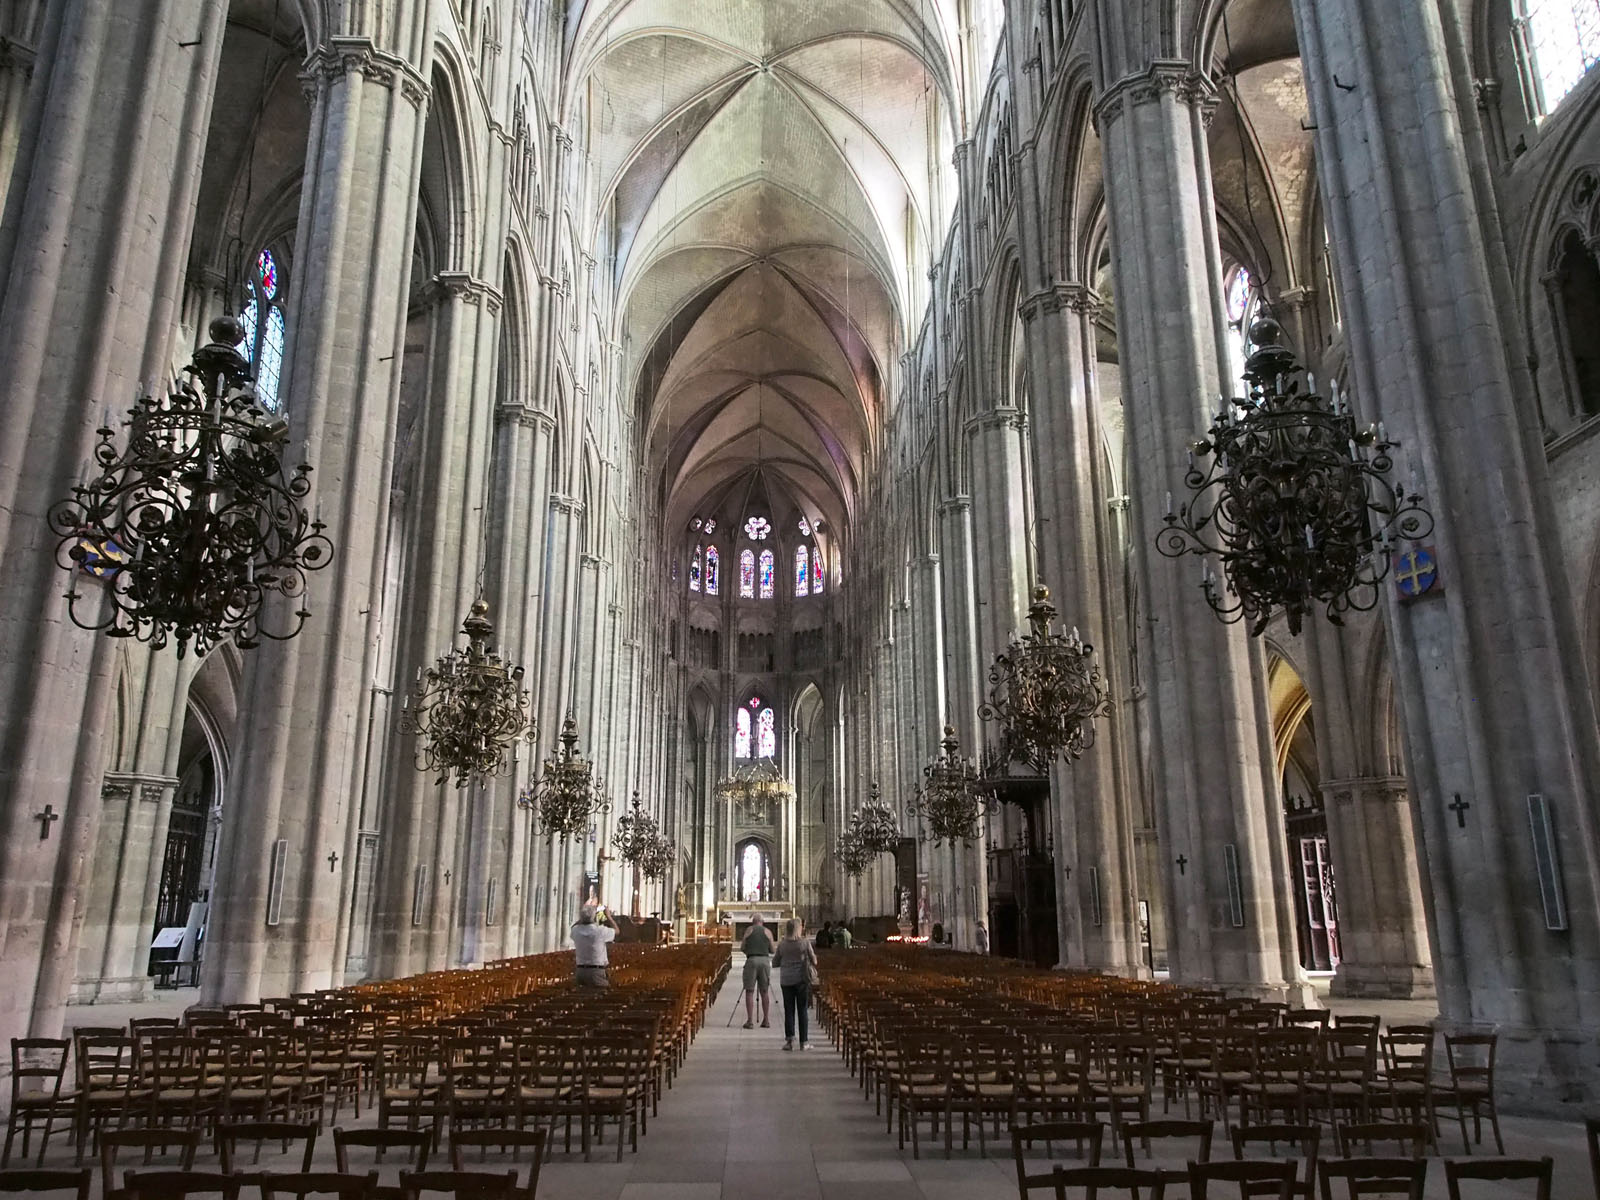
{"left": 48, "top": 317, "right": 333, "bottom": 658}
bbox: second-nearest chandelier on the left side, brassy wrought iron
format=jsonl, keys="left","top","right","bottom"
{"left": 400, "top": 597, "right": 534, "bottom": 787}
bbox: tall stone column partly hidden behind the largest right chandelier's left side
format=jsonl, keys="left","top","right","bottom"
{"left": 1094, "top": 62, "right": 1307, "bottom": 998}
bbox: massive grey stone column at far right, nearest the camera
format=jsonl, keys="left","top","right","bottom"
{"left": 1294, "top": 0, "right": 1600, "bottom": 1104}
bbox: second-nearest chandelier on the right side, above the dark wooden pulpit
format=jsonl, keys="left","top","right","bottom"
{"left": 979, "top": 584, "right": 1110, "bottom": 773}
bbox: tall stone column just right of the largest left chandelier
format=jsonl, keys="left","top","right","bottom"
{"left": 203, "top": 37, "right": 429, "bottom": 1003}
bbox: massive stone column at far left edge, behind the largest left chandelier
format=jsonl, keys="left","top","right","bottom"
{"left": 0, "top": 0, "right": 227, "bottom": 1045}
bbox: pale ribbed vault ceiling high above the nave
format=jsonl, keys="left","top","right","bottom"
{"left": 568, "top": 0, "right": 955, "bottom": 550}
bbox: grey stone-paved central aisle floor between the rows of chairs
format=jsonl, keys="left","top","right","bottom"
{"left": 539, "top": 955, "right": 1016, "bottom": 1200}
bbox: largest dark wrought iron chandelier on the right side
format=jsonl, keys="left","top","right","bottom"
{"left": 1155, "top": 317, "right": 1434, "bottom": 634}
